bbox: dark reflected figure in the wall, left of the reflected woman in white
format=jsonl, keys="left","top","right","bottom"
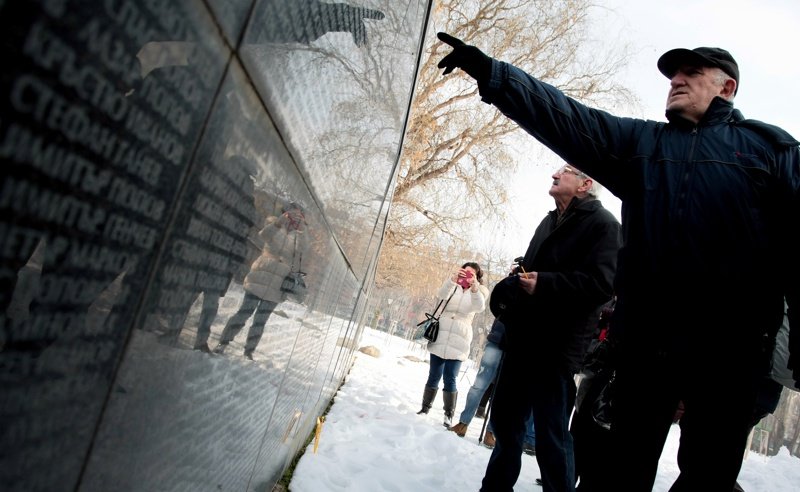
{"left": 141, "top": 155, "right": 256, "bottom": 352}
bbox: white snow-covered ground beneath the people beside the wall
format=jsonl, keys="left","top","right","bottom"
{"left": 289, "top": 328, "right": 800, "bottom": 492}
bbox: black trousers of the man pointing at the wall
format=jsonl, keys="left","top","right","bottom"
{"left": 604, "top": 352, "right": 760, "bottom": 492}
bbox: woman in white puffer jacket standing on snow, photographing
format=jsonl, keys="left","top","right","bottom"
{"left": 417, "top": 262, "right": 489, "bottom": 429}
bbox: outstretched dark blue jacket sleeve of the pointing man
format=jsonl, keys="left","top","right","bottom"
{"left": 479, "top": 60, "right": 654, "bottom": 196}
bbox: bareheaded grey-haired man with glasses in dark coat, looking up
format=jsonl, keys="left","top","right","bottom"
{"left": 481, "top": 165, "right": 621, "bottom": 492}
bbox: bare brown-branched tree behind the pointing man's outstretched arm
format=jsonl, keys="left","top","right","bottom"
{"left": 376, "top": 0, "right": 635, "bottom": 296}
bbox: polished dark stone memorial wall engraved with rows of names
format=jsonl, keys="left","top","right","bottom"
{"left": 0, "top": 0, "right": 430, "bottom": 492}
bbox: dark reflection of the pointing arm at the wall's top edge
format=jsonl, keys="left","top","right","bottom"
{"left": 252, "top": 0, "right": 384, "bottom": 47}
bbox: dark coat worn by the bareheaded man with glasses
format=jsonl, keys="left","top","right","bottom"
{"left": 501, "top": 198, "right": 621, "bottom": 373}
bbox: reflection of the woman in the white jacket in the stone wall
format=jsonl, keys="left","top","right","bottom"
{"left": 214, "top": 202, "right": 310, "bottom": 360}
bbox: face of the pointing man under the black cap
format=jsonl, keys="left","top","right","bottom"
{"left": 667, "top": 65, "right": 725, "bottom": 123}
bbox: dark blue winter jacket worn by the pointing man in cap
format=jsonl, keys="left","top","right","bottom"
{"left": 480, "top": 60, "right": 800, "bottom": 370}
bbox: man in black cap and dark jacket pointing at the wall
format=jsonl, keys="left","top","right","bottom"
{"left": 439, "top": 33, "right": 800, "bottom": 492}
